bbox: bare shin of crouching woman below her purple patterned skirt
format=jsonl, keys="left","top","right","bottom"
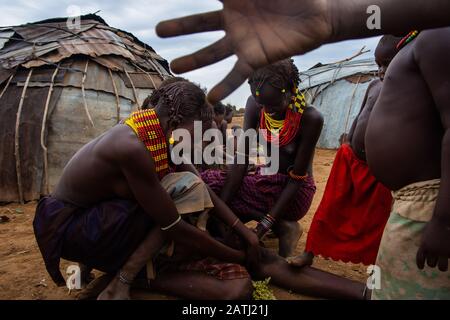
{"left": 274, "top": 220, "right": 303, "bottom": 258}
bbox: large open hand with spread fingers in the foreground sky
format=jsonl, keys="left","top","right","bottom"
{"left": 156, "top": 0, "right": 332, "bottom": 104}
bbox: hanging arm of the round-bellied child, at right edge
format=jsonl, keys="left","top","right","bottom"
{"left": 414, "top": 28, "right": 450, "bottom": 271}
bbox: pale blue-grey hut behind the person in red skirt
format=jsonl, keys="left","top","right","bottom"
{"left": 300, "top": 59, "right": 378, "bottom": 149}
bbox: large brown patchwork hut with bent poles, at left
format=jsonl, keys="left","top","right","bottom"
{"left": 0, "top": 15, "right": 171, "bottom": 202}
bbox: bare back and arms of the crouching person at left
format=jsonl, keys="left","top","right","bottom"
{"left": 53, "top": 99, "right": 259, "bottom": 298}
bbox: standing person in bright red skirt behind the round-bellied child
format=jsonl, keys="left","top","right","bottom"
{"left": 291, "top": 36, "right": 401, "bottom": 266}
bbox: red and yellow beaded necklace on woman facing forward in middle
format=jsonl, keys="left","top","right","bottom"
{"left": 259, "top": 88, "right": 306, "bottom": 147}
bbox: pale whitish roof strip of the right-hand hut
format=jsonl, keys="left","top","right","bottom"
{"left": 300, "top": 59, "right": 378, "bottom": 90}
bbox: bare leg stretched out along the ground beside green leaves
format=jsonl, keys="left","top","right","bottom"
{"left": 255, "top": 249, "right": 365, "bottom": 300}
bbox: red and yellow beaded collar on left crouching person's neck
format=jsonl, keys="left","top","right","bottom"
{"left": 125, "top": 109, "right": 169, "bottom": 179}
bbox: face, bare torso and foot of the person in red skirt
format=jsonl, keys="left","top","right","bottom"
{"left": 289, "top": 38, "right": 401, "bottom": 267}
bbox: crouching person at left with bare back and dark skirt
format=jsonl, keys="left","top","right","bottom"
{"left": 33, "top": 81, "right": 258, "bottom": 299}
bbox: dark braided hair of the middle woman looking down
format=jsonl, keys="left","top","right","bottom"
{"left": 248, "top": 59, "right": 300, "bottom": 90}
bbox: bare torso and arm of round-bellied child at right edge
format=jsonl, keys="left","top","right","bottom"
{"left": 366, "top": 28, "right": 450, "bottom": 271}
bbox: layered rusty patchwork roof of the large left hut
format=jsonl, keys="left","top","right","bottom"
{"left": 0, "top": 14, "right": 170, "bottom": 76}
